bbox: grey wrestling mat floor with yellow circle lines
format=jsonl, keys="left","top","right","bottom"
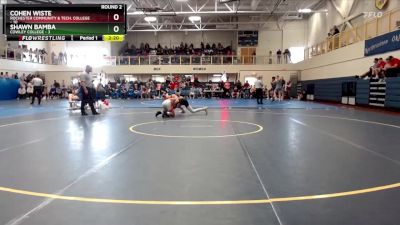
{"left": 0, "top": 100, "right": 400, "bottom": 225}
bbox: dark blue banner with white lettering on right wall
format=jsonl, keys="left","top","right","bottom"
{"left": 364, "top": 30, "right": 400, "bottom": 56}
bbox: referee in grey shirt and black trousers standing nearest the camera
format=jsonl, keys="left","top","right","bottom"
{"left": 80, "top": 65, "right": 99, "bottom": 116}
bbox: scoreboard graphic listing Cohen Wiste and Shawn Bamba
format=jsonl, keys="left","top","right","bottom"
{"left": 3, "top": 4, "right": 126, "bottom": 41}
